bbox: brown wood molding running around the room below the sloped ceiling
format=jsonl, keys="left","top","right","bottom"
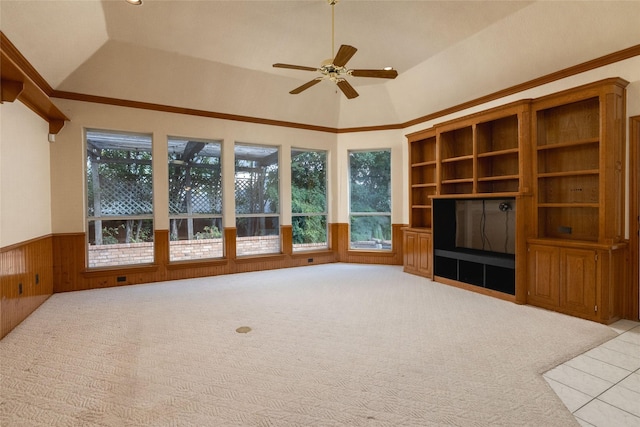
{"left": 0, "top": 31, "right": 640, "bottom": 134}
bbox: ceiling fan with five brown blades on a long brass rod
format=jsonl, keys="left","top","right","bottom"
{"left": 273, "top": 0, "right": 398, "bottom": 99}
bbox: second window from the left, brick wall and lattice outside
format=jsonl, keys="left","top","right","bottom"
{"left": 168, "top": 137, "right": 224, "bottom": 261}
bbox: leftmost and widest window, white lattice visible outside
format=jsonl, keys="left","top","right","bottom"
{"left": 86, "top": 130, "right": 153, "bottom": 267}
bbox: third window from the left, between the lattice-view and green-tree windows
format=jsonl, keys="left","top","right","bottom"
{"left": 235, "top": 144, "right": 281, "bottom": 256}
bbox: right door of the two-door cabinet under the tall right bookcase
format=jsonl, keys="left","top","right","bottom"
{"left": 560, "top": 248, "right": 597, "bottom": 318}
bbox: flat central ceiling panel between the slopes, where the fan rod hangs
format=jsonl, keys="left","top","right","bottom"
{"left": 103, "top": 0, "right": 527, "bottom": 84}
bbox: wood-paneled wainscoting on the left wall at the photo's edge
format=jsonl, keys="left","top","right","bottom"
{"left": 0, "top": 236, "right": 53, "bottom": 338}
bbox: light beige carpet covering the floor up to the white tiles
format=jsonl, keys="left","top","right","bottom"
{"left": 0, "top": 264, "right": 615, "bottom": 427}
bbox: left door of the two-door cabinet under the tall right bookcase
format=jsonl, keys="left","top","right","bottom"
{"left": 527, "top": 245, "right": 560, "bottom": 308}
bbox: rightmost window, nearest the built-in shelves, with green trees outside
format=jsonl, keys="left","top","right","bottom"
{"left": 349, "top": 150, "right": 391, "bottom": 250}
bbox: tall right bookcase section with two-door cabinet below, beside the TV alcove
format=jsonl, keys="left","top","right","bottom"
{"left": 528, "top": 79, "right": 628, "bottom": 323}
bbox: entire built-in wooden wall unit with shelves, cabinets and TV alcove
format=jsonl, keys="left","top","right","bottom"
{"left": 404, "top": 78, "right": 628, "bottom": 323}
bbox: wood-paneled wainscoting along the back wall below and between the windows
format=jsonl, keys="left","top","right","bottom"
{"left": 53, "top": 223, "right": 404, "bottom": 292}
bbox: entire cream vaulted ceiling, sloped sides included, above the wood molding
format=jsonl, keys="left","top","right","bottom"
{"left": 0, "top": 0, "right": 640, "bottom": 127}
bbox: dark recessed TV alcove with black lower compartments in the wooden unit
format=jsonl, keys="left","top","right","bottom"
{"left": 433, "top": 198, "right": 516, "bottom": 295}
